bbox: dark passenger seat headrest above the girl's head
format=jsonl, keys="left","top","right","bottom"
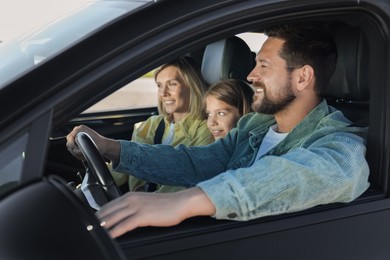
{"left": 201, "top": 36, "right": 254, "bottom": 85}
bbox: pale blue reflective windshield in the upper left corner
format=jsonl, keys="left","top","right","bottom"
{"left": 0, "top": 0, "right": 153, "bottom": 89}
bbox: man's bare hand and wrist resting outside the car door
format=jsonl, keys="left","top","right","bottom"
{"left": 96, "top": 188, "right": 215, "bottom": 238}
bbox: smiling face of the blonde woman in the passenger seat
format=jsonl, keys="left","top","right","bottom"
{"left": 156, "top": 66, "right": 190, "bottom": 122}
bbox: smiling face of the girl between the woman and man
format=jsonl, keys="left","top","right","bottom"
{"left": 206, "top": 95, "right": 241, "bottom": 139}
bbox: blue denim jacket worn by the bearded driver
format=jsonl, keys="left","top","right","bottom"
{"left": 117, "top": 100, "right": 369, "bottom": 220}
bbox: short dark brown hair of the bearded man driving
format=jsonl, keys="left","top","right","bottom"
{"left": 265, "top": 22, "right": 337, "bottom": 95}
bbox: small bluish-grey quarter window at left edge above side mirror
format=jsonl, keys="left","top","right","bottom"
{"left": 0, "top": 133, "right": 28, "bottom": 196}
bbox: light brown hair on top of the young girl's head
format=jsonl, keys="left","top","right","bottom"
{"left": 204, "top": 79, "right": 254, "bottom": 116}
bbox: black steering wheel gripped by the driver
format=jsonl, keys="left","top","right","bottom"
{"left": 75, "top": 132, "right": 121, "bottom": 202}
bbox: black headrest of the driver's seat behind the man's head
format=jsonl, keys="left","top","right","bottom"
{"left": 324, "top": 24, "right": 369, "bottom": 101}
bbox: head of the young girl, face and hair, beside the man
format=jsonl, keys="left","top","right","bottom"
{"left": 205, "top": 79, "right": 254, "bottom": 139}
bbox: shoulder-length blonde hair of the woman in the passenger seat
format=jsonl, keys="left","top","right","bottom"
{"left": 154, "top": 56, "right": 207, "bottom": 120}
